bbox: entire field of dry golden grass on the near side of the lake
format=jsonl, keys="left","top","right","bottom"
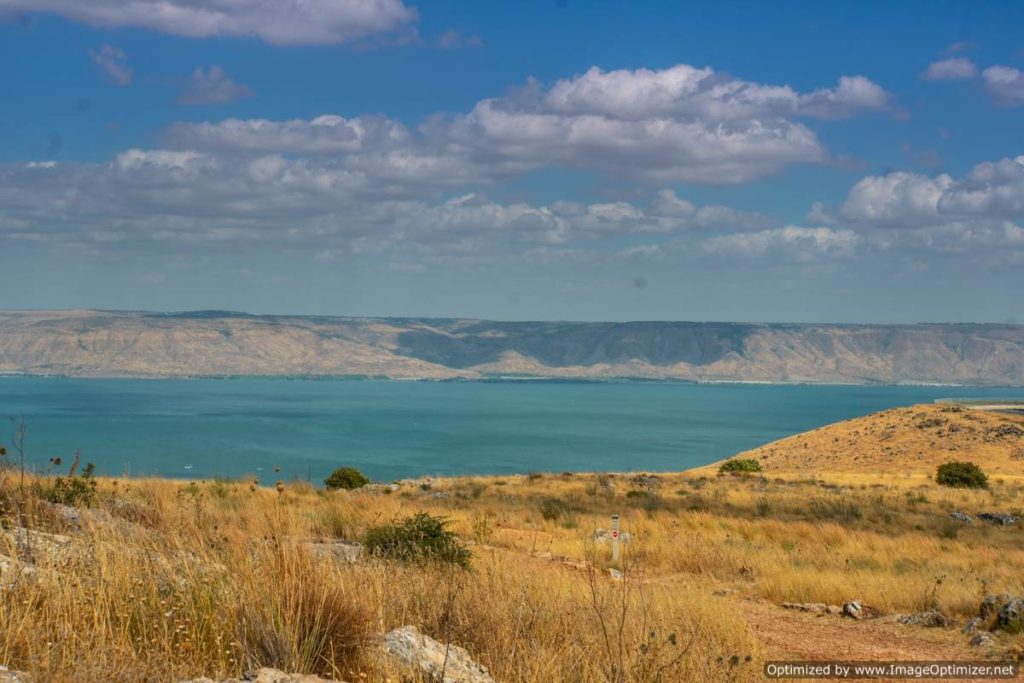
{"left": 0, "top": 409, "right": 1024, "bottom": 683}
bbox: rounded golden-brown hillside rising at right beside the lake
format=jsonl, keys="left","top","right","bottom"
{"left": 737, "top": 404, "right": 1024, "bottom": 475}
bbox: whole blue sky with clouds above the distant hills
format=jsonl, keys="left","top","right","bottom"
{"left": 0, "top": 0, "right": 1024, "bottom": 323}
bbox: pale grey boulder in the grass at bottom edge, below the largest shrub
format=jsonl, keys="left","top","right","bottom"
{"left": 384, "top": 626, "right": 495, "bottom": 683}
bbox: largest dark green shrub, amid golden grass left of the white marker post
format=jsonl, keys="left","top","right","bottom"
{"left": 362, "top": 512, "right": 471, "bottom": 567}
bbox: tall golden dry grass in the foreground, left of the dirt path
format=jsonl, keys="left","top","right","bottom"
{"left": 0, "top": 480, "right": 763, "bottom": 682}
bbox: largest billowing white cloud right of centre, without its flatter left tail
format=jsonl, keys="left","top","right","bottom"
{"left": 429, "top": 65, "right": 888, "bottom": 183}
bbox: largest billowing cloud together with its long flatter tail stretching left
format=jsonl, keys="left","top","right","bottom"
{"left": 169, "top": 65, "right": 888, "bottom": 183}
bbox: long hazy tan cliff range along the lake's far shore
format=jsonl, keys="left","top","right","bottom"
{"left": 6, "top": 310, "right": 1024, "bottom": 385}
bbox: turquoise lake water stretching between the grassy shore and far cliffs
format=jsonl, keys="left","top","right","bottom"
{"left": 0, "top": 377, "right": 1024, "bottom": 481}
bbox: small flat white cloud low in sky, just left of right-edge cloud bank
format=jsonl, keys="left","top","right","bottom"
{"left": 703, "top": 225, "right": 860, "bottom": 263}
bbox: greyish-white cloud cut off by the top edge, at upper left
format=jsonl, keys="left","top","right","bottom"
{"left": 0, "top": 0, "right": 417, "bottom": 45}
